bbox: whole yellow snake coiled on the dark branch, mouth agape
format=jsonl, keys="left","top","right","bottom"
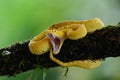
{"left": 28, "top": 18, "right": 104, "bottom": 69}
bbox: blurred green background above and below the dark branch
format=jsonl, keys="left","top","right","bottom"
{"left": 0, "top": 0, "right": 120, "bottom": 80}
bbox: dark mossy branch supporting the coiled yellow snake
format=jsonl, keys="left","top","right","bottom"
{"left": 0, "top": 24, "right": 120, "bottom": 76}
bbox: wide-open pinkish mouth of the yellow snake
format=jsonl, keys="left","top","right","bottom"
{"left": 47, "top": 33, "right": 62, "bottom": 54}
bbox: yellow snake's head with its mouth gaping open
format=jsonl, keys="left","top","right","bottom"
{"left": 46, "top": 29, "right": 65, "bottom": 54}
